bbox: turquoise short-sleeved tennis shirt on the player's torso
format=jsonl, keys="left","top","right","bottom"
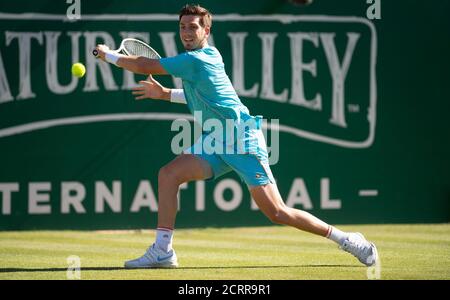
{"left": 160, "top": 46, "right": 255, "bottom": 142}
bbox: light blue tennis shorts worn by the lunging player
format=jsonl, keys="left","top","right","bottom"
{"left": 183, "top": 125, "right": 275, "bottom": 187}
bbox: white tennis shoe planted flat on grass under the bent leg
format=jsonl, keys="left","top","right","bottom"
{"left": 125, "top": 244, "right": 178, "bottom": 269}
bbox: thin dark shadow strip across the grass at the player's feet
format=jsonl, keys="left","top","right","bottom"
{"left": 0, "top": 265, "right": 364, "bottom": 273}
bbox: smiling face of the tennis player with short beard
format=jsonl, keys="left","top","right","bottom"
{"left": 180, "top": 15, "right": 209, "bottom": 51}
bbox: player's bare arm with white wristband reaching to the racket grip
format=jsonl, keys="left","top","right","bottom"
{"left": 96, "top": 45, "right": 167, "bottom": 75}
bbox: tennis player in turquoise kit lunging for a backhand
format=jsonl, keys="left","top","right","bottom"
{"left": 96, "top": 5, "right": 378, "bottom": 268}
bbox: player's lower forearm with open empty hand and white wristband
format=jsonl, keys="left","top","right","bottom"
{"left": 132, "top": 75, "right": 186, "bottom": 104}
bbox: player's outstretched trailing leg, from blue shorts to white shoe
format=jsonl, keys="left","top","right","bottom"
{"left": 221, "top": 123, "right": 378, "bottom": 265}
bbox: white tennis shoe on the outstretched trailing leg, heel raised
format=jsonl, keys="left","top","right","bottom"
{"left": 339, "top": 232, "right": 378, "bottom": 267}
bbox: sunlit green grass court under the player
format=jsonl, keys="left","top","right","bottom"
{"left": 0, "top": 224, "right": 450, "bottom": 280}
